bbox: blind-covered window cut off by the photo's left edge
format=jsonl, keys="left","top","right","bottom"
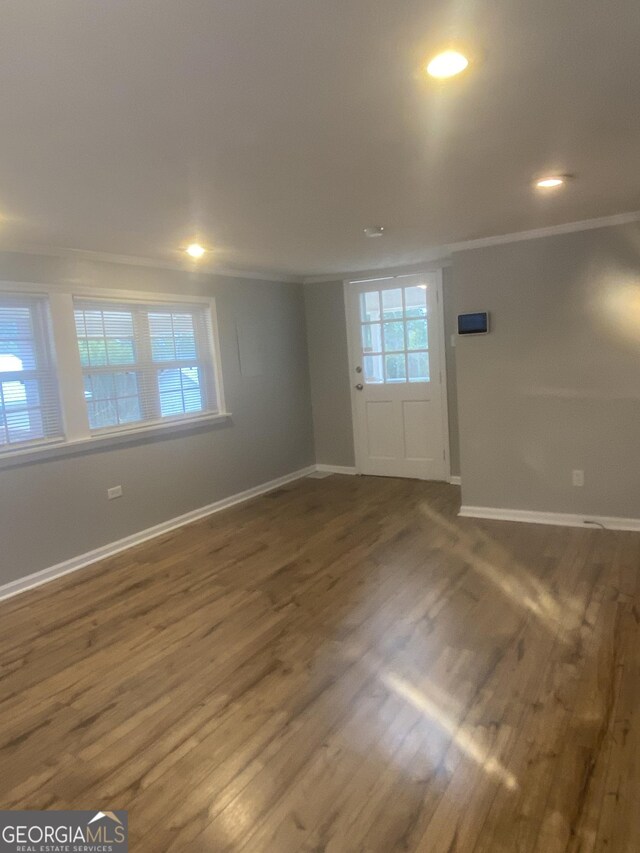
{"left": 0, "top": 294, "right": 63, "bottom": 454}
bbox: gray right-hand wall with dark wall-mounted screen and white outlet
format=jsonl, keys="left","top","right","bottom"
{"left": 453, "top": 224, "right": 640, "bottom": 518}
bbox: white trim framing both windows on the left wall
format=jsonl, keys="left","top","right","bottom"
{"left": 0, "top": 281, "right": 231, "bottom": 470}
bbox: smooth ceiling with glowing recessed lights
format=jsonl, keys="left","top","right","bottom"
{"left": 0, "top": 0, "right": 640, "bottom": 275}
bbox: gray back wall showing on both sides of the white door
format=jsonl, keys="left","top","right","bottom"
{"left": 304, "top": 268, "right": 460, "bottom": 474}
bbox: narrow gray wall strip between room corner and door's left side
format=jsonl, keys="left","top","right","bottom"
{"left": 304, "top": 281, "right": 355, "bottom": 467}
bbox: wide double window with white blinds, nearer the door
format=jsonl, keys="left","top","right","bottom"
{"left": 74, "top": 299, "right": 218, "bottom": 432}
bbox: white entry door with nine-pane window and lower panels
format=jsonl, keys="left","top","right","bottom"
{"left": 345, "top": 271, "right": 449, "bottom": 480}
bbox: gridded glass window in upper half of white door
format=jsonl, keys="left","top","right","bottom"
{"left": 360, "top": 286, "right": 430, "bottom": 385}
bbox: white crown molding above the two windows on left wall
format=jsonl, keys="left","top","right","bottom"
{"left": 0, "top": 245, "right": 302, "bottom": 284}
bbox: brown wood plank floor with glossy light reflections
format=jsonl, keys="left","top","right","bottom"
{"left": 0, "top": 476, "right": 640, "bottom": 853}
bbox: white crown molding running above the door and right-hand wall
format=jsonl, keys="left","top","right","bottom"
{"left": 302, "top": 210, "right": 640, "bottom": 284}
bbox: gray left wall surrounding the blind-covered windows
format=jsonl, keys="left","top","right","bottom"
{"left": 0, "top": 253, "right": 315, "bottom": 584}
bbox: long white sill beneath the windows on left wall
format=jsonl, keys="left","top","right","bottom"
{"left": 0, "top": 412, "right": 231, "bottom": 470}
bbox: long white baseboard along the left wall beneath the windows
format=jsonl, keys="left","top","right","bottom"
{"left": 0, "top": 465, "right": 316, "bottom": 601}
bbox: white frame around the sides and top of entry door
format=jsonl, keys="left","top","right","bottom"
{"left": 342, "top": 266, "right": 451, "bottom": 482}
